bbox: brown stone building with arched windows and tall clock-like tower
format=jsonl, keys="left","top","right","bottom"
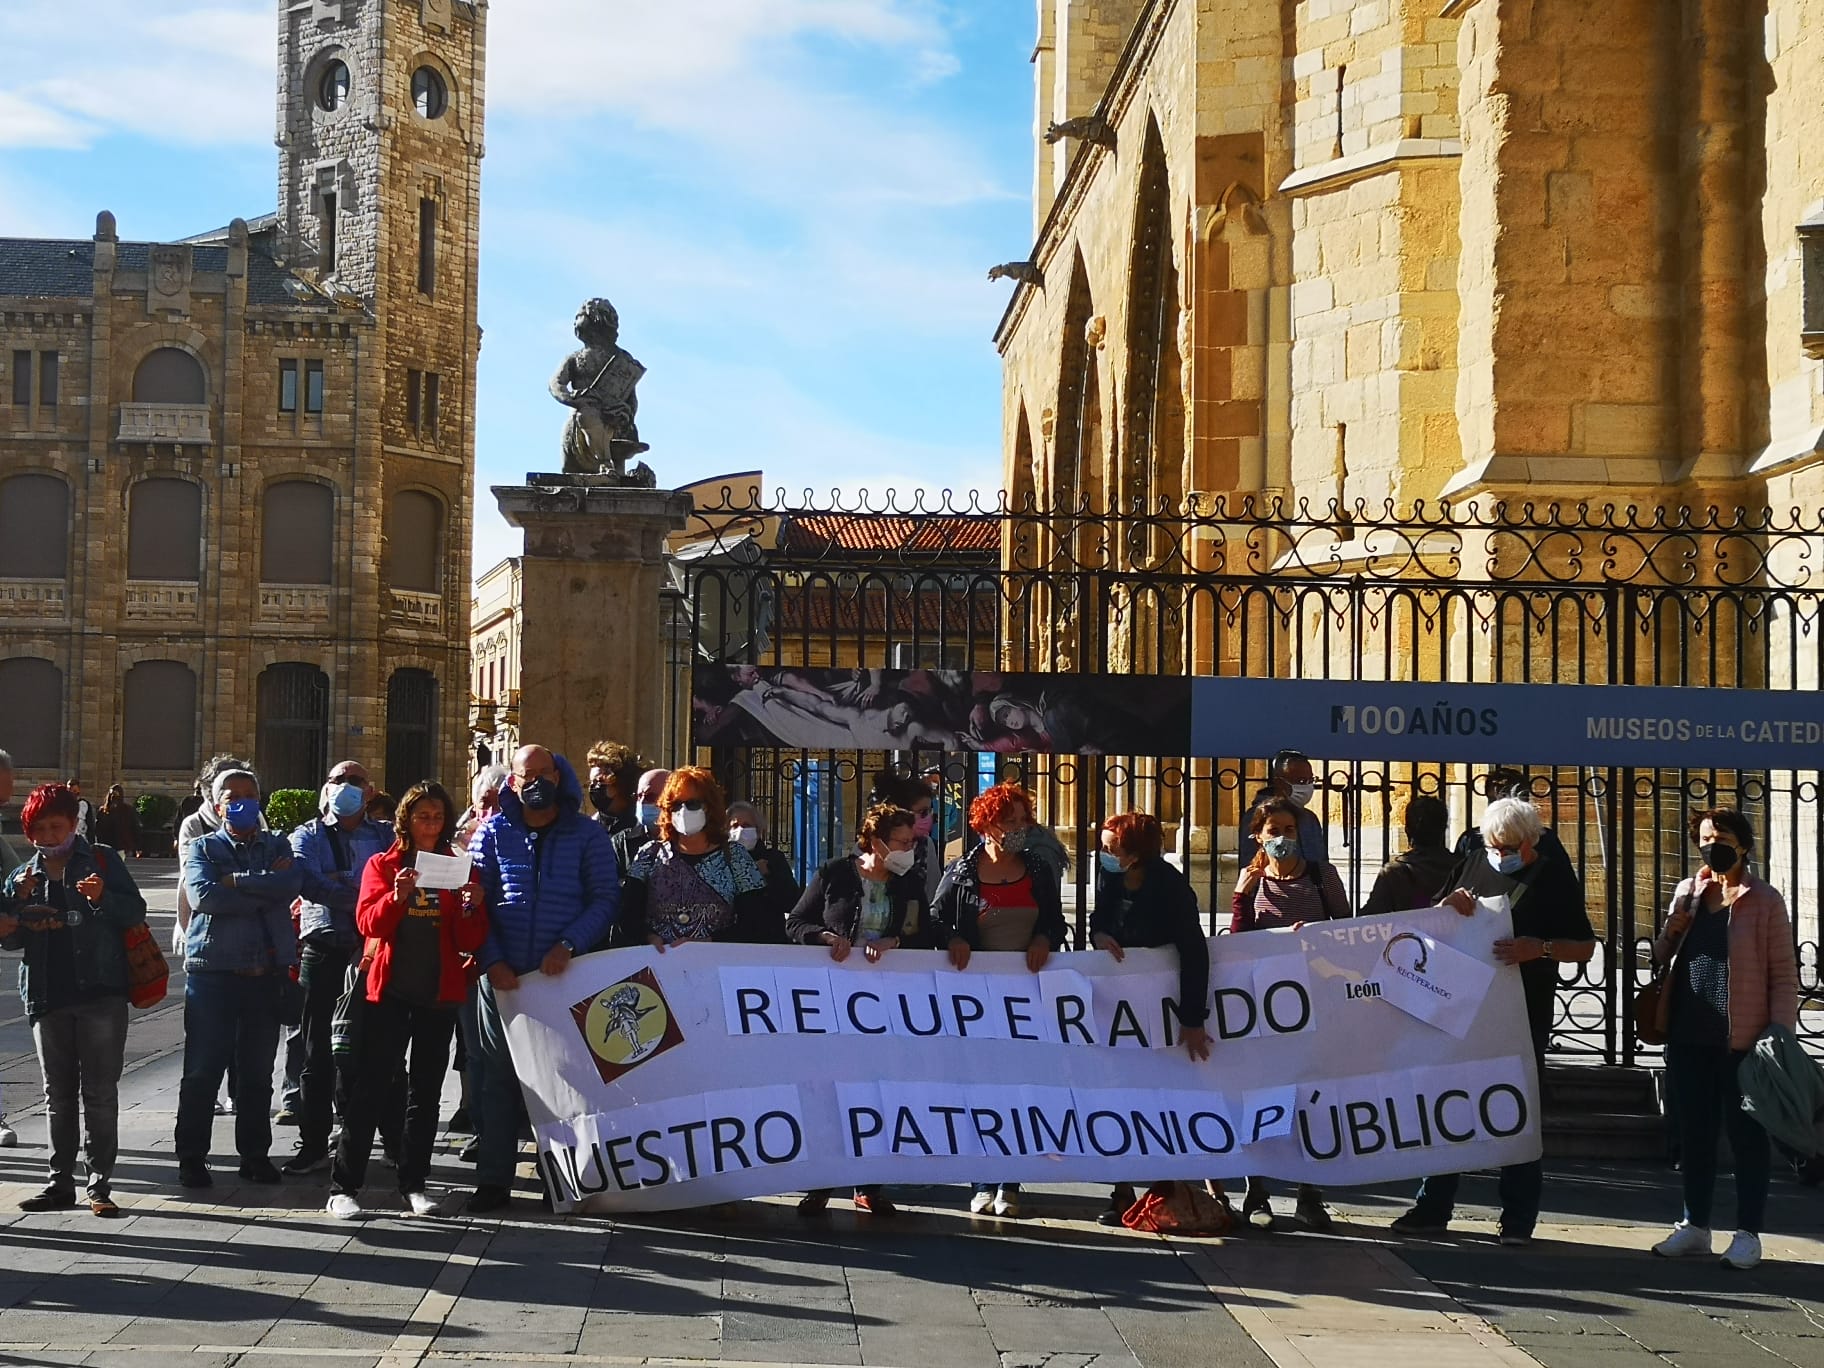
{"left": 0, "top": 0, "right": 487, "bottom": 792}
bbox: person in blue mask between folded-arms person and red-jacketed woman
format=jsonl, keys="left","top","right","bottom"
{"left": 277, "top": 761, "right": 394, "bottom": 1175}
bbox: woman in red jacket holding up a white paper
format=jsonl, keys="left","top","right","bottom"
{"left": 328, "top": 782, "right": 487, "bottom": 1220}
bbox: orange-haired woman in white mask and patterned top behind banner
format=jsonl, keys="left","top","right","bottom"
{"left": 620, "top": 766, "right": 784, "bottom": 952}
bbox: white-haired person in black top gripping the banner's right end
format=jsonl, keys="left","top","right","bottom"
{"left": 1394, "top": 797, "right": 1596, "bottom": 1246}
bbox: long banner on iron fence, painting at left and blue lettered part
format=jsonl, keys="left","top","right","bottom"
{"left": 693, "top": 666, "right": 1824, "bottom": 770}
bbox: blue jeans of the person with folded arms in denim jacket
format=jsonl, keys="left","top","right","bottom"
{"left": 173, "top": 969, "right": 279, "bottom": 1164}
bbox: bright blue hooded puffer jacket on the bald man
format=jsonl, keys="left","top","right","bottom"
{"left": 469, "top": 755, "right": 620, "bottom": 974}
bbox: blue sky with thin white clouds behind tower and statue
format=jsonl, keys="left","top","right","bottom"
{"left": 0, "top": 0, "right": 1034, "bottom": 569}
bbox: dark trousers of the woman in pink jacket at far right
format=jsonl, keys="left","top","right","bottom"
{"left": 1665, "top": 1042, "right": 1773, "bottom": 1235}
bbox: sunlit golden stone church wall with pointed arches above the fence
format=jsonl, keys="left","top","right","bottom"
{"left": 996, "top": 0, "right": 1824, "bottom": 532}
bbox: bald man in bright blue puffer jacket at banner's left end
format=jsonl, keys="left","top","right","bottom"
{"left": 469, "top": 746, "right": 620, "bottom": 1215}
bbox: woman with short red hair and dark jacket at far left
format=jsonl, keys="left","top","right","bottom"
{"left": 0, "top": 784, "right": 146, "bottom": 1217}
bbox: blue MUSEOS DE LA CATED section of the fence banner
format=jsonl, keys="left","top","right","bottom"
{"left": 1191, "top": 679, "right": 1824, "bottom": 770}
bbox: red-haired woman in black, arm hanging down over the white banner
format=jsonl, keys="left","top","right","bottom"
{"left": 1089, "top": 812, "right": 1209, "bottom": 1226}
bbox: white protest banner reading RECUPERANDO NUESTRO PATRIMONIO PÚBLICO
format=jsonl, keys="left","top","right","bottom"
{"left": 500, "top": 907, "right": 1539, "bottom": 1211}
